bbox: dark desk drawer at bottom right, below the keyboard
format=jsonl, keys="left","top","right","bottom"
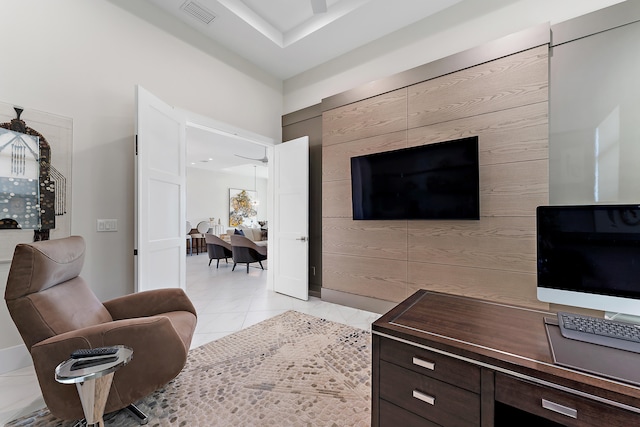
{"left": 495, "top": 374, "right": 640, "bottom": 427}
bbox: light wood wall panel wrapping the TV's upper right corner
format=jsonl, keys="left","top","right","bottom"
{"left": 407, "top": 102, "right": 549, "bottom": 165}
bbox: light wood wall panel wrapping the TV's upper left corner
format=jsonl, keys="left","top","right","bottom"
{"left": 322, "top": 130, "right": 407, "bottom": 181}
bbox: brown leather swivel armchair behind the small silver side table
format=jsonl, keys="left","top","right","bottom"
{"left": 5, "top": 236, "right": 196, "bottom": 420}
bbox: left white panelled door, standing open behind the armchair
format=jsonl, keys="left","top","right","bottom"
{"left": 135, "top": 86, "right": 187, "bottom": 292}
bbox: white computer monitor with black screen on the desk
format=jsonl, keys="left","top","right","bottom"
{"left": 536, "top": 204, "right": 640, "bottom": 316}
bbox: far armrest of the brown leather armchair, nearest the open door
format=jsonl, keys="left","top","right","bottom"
{"left": 103, "top": 288, "right": 196, "bottom": 320}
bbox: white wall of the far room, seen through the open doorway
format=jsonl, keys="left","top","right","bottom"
{"left": 187, "top": 168, "right": 268, "bottom": 232}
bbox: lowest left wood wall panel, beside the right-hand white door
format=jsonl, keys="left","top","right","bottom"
{"left": 322, "top": 253, "right": 408, "bottom": 302}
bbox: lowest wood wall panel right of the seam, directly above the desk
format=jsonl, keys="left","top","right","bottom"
{"left": 407, "top": 262, "right": 549, "bottom": 310}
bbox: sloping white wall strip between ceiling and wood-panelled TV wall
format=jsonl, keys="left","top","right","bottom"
{"left": 284, "top": 0, "right": 622, "bottom": 114}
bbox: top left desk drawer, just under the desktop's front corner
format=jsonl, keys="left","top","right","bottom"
{"left": 380, "top": 339, "right": 480, "bottom": 393}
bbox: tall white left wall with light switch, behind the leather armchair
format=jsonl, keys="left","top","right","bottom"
{"left": 0, "top": 0, "right": 282, "bottom": 358}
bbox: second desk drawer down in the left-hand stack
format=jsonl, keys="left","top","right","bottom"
{"left": 380, "top": 360, "right": 480, "bottom": 427}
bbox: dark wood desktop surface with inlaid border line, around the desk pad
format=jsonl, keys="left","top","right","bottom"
{"left": 372, "top": 290, "right": 640, "bottom": 411}
